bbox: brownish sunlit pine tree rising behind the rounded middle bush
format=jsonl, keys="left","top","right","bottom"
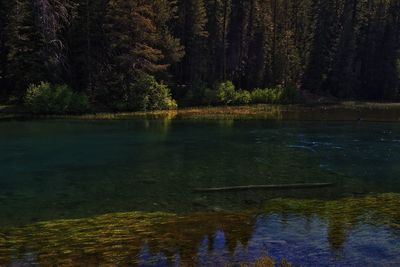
{"left": 103, "top": 0, "right": 168, "bottom": 100}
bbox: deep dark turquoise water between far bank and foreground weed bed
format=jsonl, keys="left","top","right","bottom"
{"left": 0, "top": 120, "right": 400, "bottom": 225}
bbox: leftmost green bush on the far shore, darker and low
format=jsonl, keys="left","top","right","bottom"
{"left": 24, "top": 82, "right": 89, "bottom": 114}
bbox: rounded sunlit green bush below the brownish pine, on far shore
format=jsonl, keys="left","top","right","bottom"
{"left": 115, "top": 75, "right": 178, "bottom": 111}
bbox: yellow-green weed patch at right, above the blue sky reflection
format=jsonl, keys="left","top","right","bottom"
{"left": 265, "top": 194, "right": 400, "bottom": 253}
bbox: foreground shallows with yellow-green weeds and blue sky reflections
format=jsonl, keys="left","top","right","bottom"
{"left": 0, "top": 194, "right": 400, "bottom": 266}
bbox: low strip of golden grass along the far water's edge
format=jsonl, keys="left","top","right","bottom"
{"left": 0, "top": 102, "right": 400, "bottom": 122}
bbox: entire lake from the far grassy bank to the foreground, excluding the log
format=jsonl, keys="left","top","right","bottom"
{"left": 0, "top": 118, "right": 400, "bottom": 266}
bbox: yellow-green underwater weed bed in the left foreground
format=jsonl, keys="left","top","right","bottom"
{"left": 0, "top": 212, "right": 255, "bottom": 266}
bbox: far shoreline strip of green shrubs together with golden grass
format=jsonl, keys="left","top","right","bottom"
{"left": 0, "top": 75, "right": 400, "bottom": 121}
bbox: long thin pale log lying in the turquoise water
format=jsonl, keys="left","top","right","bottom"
{"left": 194, "top": 183, "right": 335, "bottom": 192}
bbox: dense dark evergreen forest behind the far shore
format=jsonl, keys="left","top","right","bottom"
{"left": 0, "top": 0, "right": 400, "bottom": 109}
